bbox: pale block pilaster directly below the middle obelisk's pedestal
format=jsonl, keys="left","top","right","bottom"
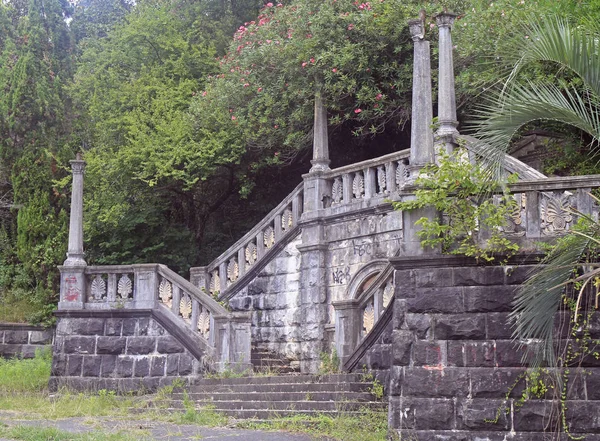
{"left": 297, "top": 220, "right": 328, "bottom": 373}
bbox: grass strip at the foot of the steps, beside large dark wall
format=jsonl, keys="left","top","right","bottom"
{"left": 237, "top": 410, "right": 388, "bottom": 441}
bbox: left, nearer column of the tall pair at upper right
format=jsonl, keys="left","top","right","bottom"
{"left": 408, "top": 19, "right": 435, "bottom": 184}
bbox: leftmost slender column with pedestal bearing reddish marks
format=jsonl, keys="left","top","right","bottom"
{"left": 58, "top": 153, "right": 87, "bottom": 310}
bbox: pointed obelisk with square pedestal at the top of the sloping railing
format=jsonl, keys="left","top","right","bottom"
{"left": 303, "top": 90, "right": 331, "bottom": 213}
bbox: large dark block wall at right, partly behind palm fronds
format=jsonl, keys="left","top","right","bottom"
{"left": 390, "top": 257, "right": 600, "bottom": 441}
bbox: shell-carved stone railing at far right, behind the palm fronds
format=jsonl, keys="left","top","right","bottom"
{"left": 504, "top": 175, "right": 600, "bottom": 239}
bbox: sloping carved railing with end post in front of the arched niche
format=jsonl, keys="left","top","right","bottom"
{"left": 333, "top": 264, "right": 394, "bottom": 367}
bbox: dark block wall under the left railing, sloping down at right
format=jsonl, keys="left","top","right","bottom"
{"left": 50, "top": 310, "right": 203, "bottom": 392}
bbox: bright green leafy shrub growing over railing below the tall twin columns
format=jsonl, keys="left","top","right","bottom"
{"left": 393, "top": 149, "right": 518, "bottom": 261}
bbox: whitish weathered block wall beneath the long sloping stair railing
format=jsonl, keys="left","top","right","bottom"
{"left": 229, "top": 236, "right": 301, "bottom": 359}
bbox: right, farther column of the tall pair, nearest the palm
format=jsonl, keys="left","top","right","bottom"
{"left": 435, "top": 12, "right": 458, "bottom": 153}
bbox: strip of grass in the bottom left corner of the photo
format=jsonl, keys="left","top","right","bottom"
{"left": 0, "top": 425, "right": 147, "bottom": 441}
